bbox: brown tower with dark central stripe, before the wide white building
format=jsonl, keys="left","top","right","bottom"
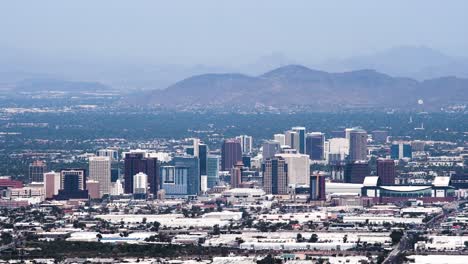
{"left": 262, "top": 157, "right": 288, "bottom": 194}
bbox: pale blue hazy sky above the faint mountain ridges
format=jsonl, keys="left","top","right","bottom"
{"left": 0, "top": 0, "right": 468, "bottom": 64}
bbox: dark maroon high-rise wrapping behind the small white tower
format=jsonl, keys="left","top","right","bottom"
{"left": 124, "top": 152, "right": 159, "bottom": 195}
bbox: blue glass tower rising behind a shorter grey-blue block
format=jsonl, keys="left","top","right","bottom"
{"left": 172, "top": 156, "right": 201, "bottom": 196}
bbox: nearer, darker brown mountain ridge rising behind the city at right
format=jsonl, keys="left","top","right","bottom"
{"left": 142, "top": 65, "right": 468, "bottom": 111}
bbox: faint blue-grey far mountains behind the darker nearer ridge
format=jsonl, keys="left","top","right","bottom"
{"left": 0, "top": 44, "right": 468, "bottom": 92}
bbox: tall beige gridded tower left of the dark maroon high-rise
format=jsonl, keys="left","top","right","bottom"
{"left": 89, "top": 156, "right": 111, "bottom": 197}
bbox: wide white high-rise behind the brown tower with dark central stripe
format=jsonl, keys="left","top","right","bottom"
{"left": 276, "top": 153, "right": 310, "bottom": 186}
